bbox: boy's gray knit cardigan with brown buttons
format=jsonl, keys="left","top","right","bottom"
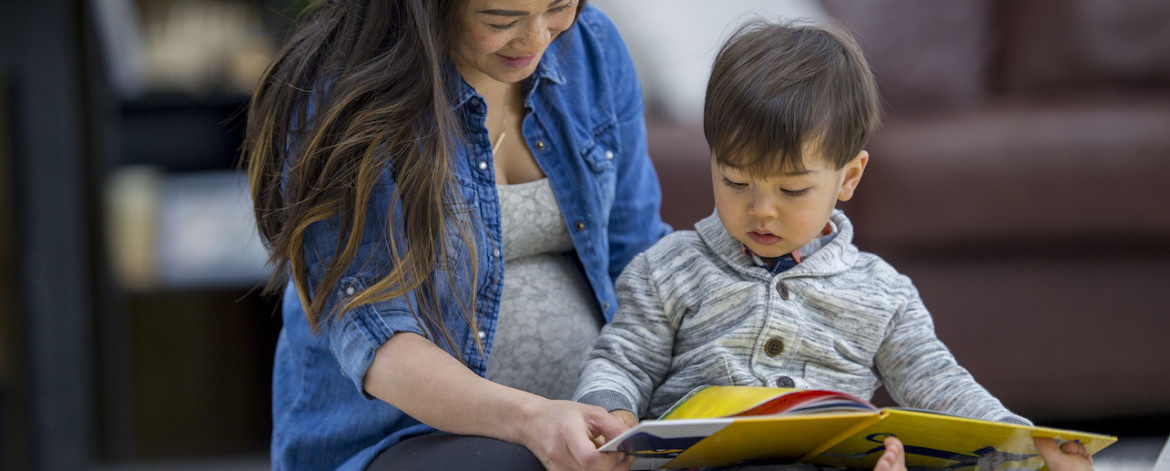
{"left": 573, "top": 210, "right": 1031, "bottom": 424}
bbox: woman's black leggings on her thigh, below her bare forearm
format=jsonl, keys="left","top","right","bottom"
{"left": 366, "top": 432, "right": 544, "bottom": 471}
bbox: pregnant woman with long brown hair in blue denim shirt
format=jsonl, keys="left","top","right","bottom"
{"left": 246, "top": 0, "right": 669, "bottom": 470}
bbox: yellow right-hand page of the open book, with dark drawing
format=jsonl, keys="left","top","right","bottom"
{"left": 806, "top": 409, "right": 1117, "bottom": 470}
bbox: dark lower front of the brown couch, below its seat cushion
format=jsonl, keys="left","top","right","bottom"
{"left": 886, "top": 252, "right": 1170, "bottom": 423}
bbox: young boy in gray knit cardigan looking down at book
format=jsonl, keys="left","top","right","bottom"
{"left": 574, "top": 20, "right": 1095, "bottom": 469}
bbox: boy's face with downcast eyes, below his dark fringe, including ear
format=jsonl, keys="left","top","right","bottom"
{"left": 711, "top": 151, "right": 869, "bottom": 258}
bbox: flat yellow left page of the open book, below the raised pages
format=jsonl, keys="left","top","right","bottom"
{"left": 663, "top": 411, "right": 879, "bottom": 467}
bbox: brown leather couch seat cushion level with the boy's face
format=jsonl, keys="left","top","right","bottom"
{"left": 852, "top": 98, "right": 1170, "bottom": 249}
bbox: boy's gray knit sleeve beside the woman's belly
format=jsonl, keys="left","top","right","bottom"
{"left": 573, "top": 252, "right": 675, "bottom": 418}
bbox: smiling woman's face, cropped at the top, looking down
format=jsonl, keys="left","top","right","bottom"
{"left": 450, "top": 0, "right": 579, "bottom": 86}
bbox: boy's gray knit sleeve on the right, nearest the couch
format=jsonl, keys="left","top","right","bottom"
{"left": 874, "top": 291, "right": 1032, "bottom": 425}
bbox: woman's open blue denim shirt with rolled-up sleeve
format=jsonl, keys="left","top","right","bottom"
{"left": 271, "top": 6, "right": 670, "bottom": 470}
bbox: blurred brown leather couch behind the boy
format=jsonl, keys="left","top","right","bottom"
{"left": 648, "top": 0, "right": 1170, "bottom": 425}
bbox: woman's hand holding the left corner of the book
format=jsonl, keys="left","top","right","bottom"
{"left": 521, "top": 400, "right": 633, "bottom": 471}
